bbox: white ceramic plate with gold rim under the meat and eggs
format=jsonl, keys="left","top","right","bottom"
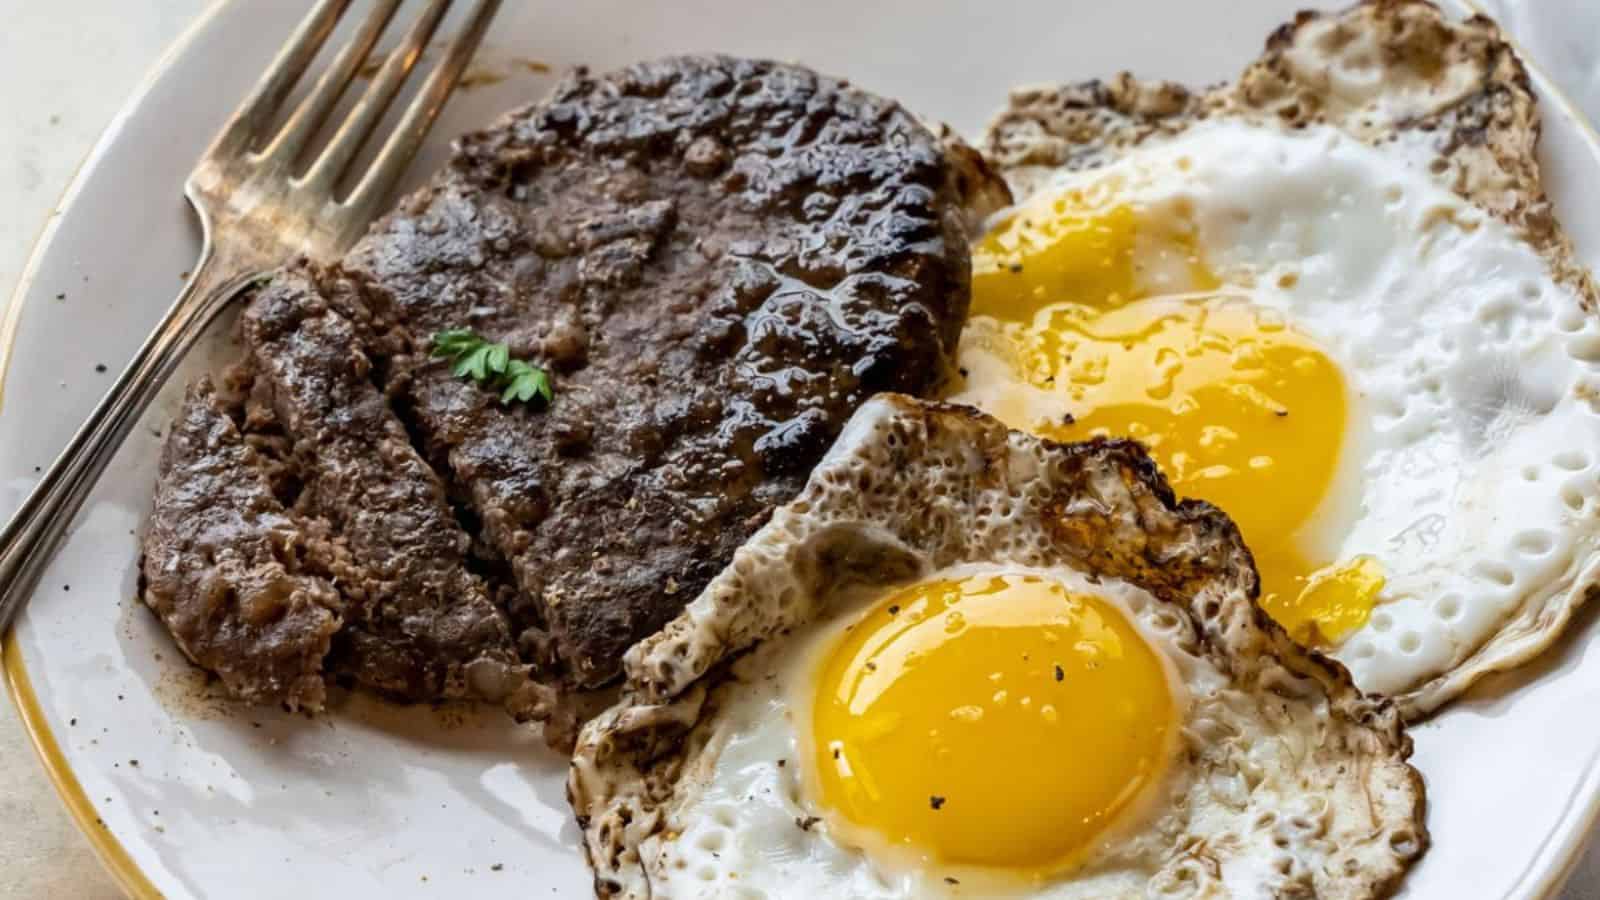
{"left": 0, "top": 0, "right": 1600, "bottom": 898}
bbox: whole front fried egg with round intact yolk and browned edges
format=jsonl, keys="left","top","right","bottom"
{"left": 570, "top": 396, "right": 1427, "bottom": 900}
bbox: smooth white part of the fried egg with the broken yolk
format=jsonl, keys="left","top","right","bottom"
{"left": 957, "top": 119, "right": 1600, "bottom": 708}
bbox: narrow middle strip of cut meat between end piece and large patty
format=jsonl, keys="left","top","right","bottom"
{"left": 242, "top": 267, "right": 526, "bottom": 700}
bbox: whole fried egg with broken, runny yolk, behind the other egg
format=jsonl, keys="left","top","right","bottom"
{"left": 950, "top": 3, "right": 1600, "bottom": 716}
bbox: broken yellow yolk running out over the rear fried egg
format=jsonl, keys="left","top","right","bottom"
{"left": 962, "top": 181, "right": 1382, "bottom": 644}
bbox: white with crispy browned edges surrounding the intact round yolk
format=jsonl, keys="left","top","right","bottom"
{"left": 570, "top": 394, "right": 1427, "bottom": 900}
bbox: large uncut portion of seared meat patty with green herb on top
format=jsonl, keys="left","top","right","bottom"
{"left": 334, "top": 58, "right": 1003, "bottom": 687}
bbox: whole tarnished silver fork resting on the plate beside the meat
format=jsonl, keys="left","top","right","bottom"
{"left": 0, "top": 0, "right": 501, "bottom": 634}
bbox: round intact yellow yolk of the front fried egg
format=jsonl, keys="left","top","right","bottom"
{"left": 811, "top": 575, "right": 1176, "bottom": 873}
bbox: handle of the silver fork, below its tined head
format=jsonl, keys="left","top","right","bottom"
{"left": 0, "top": 240, "right": 261, "bottom": 634}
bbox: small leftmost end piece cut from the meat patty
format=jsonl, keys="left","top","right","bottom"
{"left": 142, "top": 378, "right": 342, "bottom": 709}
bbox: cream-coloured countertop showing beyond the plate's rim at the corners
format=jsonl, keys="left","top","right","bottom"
{"left": 9, "top": 0, "right": 1600, "bottom": 900}
